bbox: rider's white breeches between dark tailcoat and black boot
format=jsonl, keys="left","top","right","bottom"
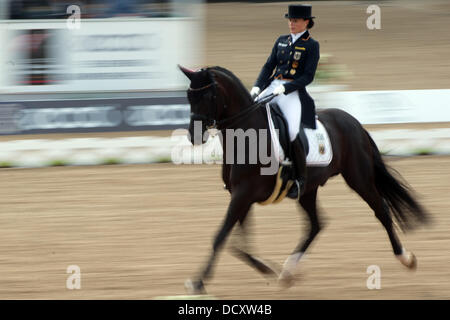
{"left": 258, "top": 79, "right": 302, "bottom": 141}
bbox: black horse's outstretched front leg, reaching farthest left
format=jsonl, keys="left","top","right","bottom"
{"left": 185, "top": 188, "right": 252, "bottom": 294}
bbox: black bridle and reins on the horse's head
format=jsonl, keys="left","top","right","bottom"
{"left": 188, "top": 81, "right": 275, "bottom": 130}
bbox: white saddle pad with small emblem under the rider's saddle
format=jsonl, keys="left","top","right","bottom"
{"left": 266, "top": 104, "right": 333, "bottom": 167}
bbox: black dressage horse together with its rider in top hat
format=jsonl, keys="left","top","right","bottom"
{"left": 180, "top": 5, "right": 428, "bottom": 293}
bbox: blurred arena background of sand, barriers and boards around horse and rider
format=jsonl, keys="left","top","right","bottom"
{"left": 0, "top": 0, "right": 450, "bottom": 299}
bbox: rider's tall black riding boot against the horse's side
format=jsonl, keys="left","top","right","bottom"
{"left": 287, "top": 135, "right": 306, "bottom": 199}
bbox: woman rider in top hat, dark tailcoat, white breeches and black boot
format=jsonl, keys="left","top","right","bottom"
{"left": 250, "top": 5, "right": 320, "bottom": 199}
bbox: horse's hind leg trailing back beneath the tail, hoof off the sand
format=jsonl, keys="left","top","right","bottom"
{"left": 342, "top": 166, "right": 417, "bottom": 269}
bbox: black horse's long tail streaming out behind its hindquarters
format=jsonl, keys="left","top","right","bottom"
{"left": 366, "top": 131, "right": 429, "bottom": 231}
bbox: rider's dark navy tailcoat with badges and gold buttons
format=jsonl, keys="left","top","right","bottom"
{"left": 255, "top": 31, "right": 320, "bottom": 129}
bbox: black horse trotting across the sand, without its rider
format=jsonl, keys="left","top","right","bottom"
{"left": 180, "top": 66, "right": 428, "bottom": 293}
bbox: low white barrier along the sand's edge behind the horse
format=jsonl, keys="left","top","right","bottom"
{"left": 0, "top": 128, "right": 450, "bottom": 167}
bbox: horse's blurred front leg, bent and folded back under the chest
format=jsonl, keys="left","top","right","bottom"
{"left": 231, "top": 212, "right": 278, "bottom": 276}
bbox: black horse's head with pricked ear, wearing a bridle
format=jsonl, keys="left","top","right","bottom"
{"left": 178, "top": 66, "right": 223, "bottom": 144}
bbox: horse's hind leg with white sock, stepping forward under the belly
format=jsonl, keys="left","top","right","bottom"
{"left": 278, "top": 188, "right": 320, "bottom": 287}
